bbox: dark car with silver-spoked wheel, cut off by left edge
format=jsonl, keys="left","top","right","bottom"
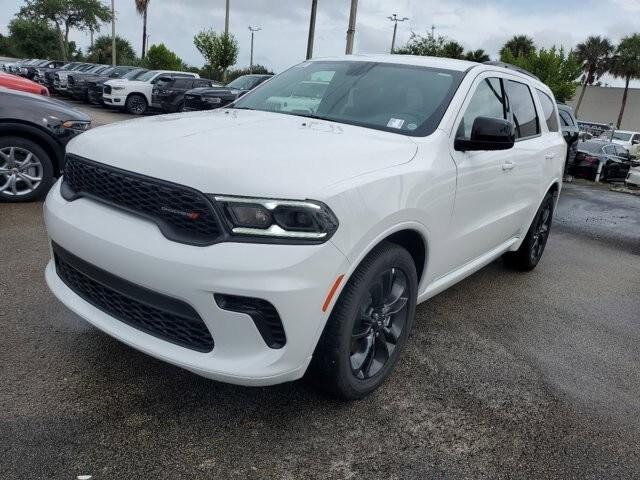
{"left": 0, "top": 87, "right": 91, "bottom": 202}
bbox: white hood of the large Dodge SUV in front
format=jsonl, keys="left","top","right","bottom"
{"left": 67, "top": 109, "right": 417, "bottom": 200}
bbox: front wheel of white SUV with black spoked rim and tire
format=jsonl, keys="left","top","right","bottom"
{"left": 308, "top": 242, "right": 418, "bottom": 400}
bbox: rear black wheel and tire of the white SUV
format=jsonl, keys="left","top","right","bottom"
{"left": 503, "top": 193, "right": 554, "bottom": 271}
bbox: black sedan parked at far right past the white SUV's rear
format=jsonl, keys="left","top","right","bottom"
{"left": 568, "top": 139, "right": 631, "bottom": 181}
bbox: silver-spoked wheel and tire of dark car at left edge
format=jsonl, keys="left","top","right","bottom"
{"left": 0, "top": 137, "right": 53, "bottom": 203}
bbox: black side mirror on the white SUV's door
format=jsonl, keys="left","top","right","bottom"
{"left": 453, "top": 117, "right": 516, "bottom": 152}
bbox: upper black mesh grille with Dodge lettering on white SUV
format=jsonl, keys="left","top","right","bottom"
{"left": 62, "top": 155, "right": 224, "bottom": 246}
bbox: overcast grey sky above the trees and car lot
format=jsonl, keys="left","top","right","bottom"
{"left": 0, "top": 0, "right": 640, "bottom": 86}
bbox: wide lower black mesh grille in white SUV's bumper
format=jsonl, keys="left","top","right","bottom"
{"left": 52, "top": 243, "right": 213, "bottom": 352}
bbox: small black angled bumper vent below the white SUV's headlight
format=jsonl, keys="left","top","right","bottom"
{"left": 215, "top": 293, "right": 287, "bottom": 348}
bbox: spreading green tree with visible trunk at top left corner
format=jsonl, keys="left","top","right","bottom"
{"left": 19, "top": 0, "right": 111, "bottom": 60}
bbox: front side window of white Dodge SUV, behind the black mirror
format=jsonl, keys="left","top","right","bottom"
{"left": 456, "top": 78, "right": 506, "bottom": 140}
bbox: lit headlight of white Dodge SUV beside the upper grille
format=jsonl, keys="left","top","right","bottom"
{"left": 209, "top": 195, "right": 338, "bottom": 242}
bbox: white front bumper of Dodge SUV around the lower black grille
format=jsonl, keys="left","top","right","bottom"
{"left": 44, "top": 182, "right": 348, "bottom": 385}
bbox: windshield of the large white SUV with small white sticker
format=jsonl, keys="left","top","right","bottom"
{"left": 235, "top": 61, "right": 464, "bottom": 136}
